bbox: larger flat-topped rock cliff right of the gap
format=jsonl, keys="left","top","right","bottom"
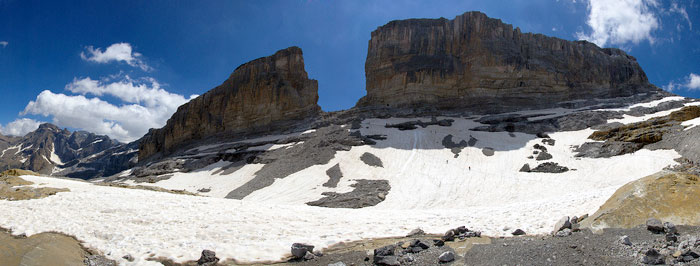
{"left": 358, "top": 12, "right": 659, "bottom": 112}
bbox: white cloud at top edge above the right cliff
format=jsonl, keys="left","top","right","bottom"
{"left": 576, "top": 0, "right": 659, "bottom": 46}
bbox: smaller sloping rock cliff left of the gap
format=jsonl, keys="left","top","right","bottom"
{"left": 139, "top": 47, "right": 321, "bottom": 161}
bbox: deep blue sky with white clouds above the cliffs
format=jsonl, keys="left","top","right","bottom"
{"left": 0, "top": 0, "right": 700, "bottom": 141}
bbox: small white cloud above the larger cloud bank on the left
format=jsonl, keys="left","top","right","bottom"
{"left": 80, "top": 42, "right": 151, "bottom": 71}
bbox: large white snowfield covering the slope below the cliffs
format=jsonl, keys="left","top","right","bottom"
{"left": 0, "top": 99, "right": 697, "bottom": 265}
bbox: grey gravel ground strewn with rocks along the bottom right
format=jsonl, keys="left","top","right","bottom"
{"left": 284, "top": 225, "right": 700, "bottom": 266}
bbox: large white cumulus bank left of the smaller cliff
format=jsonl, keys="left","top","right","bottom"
{"left": 21, "top": 77, "right": 196, "bottom": 142}
